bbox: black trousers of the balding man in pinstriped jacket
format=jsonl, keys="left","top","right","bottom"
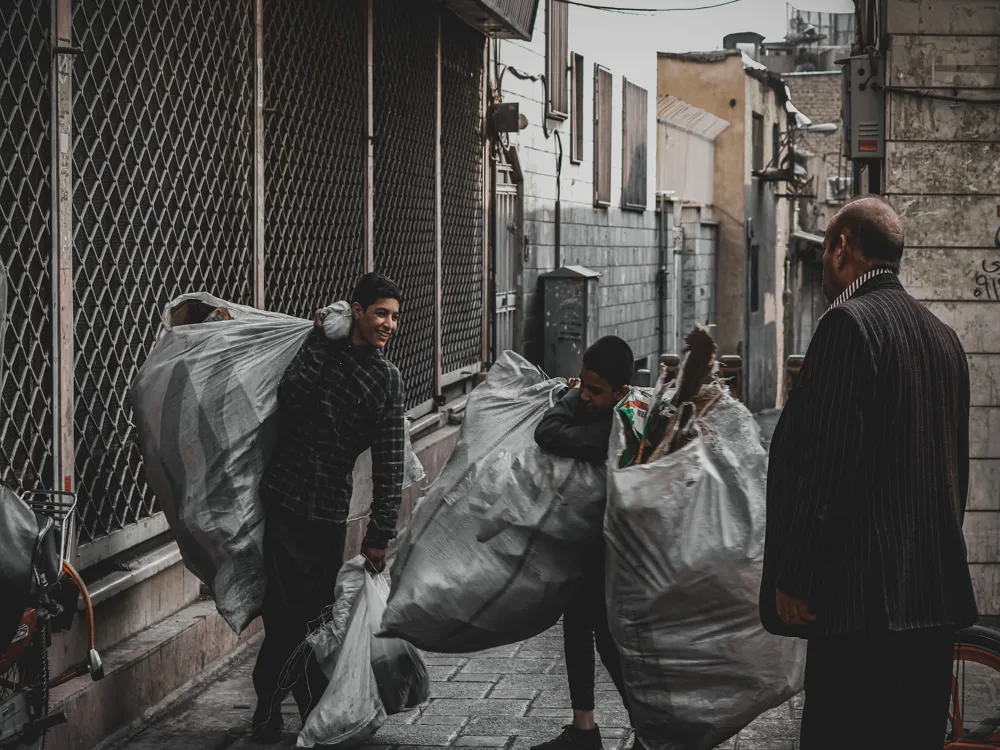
{"left": 800, "top": 630, "right": 955, "bottom": 750}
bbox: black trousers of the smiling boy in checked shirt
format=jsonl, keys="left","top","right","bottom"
{"left": 253, "top": 508, "right": 346, "bottom": 725}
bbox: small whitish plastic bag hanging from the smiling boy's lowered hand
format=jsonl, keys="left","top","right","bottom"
{"left": 297, "top": 556, "right": 431, "bottom": 748}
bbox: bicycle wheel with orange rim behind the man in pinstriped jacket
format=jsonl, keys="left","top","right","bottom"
{"left": 944, "top": 626, "right": 1000, "bottom": 750}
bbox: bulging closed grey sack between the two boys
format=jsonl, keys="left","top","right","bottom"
{"left": 382, "top": 352, "right": 605, "bottom": 653}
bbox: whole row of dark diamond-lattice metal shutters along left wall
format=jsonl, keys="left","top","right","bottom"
{"left": 0, "top": 0, "right": 484, "bottom": 564}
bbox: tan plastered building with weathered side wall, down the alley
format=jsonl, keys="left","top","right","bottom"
{"left": 657, "top": 49, "right": 792, "bottom": 411}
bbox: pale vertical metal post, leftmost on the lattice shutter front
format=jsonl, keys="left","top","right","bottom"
{"left": 52, "top": 0, "right": 76, "bottom": 508}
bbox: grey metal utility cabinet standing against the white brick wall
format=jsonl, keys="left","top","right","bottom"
{"left": 539, "top": 266, "right": 601, "bottom": 378}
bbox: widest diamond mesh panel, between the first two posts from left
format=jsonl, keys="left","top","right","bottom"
{"left": 73, "top": 0, "right": 253, "bottom": 542}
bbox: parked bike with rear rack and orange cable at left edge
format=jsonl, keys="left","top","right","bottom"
{"left": 0, "top": 485, "right": 104, "bottom": 750}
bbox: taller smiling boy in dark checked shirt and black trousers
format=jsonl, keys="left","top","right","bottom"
{"left": 252, "top": 273, "right": 404, "bottom": 744}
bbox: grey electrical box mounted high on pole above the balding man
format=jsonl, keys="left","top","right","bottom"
{"left": 837, "top": 55, "right": 885, "bottom": 160}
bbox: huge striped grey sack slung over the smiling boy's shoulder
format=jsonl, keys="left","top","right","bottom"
{"left": 130, "top": 293, "right": 423, "bottom": 633}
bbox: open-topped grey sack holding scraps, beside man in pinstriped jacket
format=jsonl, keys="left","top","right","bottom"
{"left": 604, "top": 394, "right": 805, "bottom": 750}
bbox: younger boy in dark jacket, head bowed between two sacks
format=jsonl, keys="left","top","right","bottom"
{"left": 532, "top": 336, "right": 642, "bottom": 750}
